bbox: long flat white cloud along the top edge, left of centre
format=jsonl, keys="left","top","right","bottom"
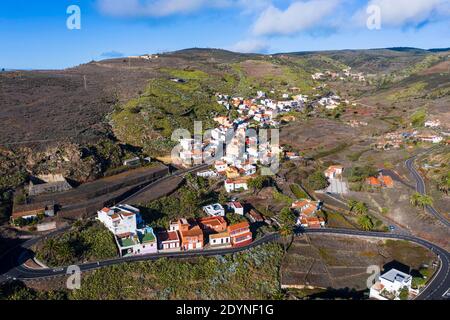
{"left": 97, "top": 0, "right": 271, "bottom": 17}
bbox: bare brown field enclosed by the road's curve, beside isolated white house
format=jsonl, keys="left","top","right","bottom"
{"left": 281, "top": 235, "right": 435, "bottom": 291}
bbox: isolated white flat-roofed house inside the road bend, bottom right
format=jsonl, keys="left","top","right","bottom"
{"left": 370, "top": 269, "right": 412, "bottom": 300}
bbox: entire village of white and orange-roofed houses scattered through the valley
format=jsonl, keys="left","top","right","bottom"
{"left": 2, "top": 57, "right": 448, "bottom": 300}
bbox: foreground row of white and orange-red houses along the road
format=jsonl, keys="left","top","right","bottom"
{"left": 97, "top": 202, "right": 253, "bottom": 257}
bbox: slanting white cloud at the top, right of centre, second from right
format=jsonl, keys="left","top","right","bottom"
{"left": 253, "top": 0, "right": 341, "bottom": 35}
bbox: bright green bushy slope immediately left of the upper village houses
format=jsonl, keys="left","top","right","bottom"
{"left": 112, "top": 69, "right": 234, "bottom": 155}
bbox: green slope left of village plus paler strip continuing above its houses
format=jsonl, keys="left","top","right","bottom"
{"left": 111, "top": 58, "right": 313, "bottom": 156}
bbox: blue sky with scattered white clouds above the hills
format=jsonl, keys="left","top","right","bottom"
{"left": 0, "top": 0, "right": 450, "bottom": 69}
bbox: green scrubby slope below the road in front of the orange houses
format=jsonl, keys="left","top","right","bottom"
{"left": 69, "top": 244, "right": 282, "bottom": 300}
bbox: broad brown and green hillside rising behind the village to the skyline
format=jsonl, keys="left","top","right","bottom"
{"left": 0, "top": 48, "right": 450, "bottom": 194}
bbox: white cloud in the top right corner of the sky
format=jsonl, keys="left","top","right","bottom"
{"left": 353, "top": 0, "right": 450, "bottom": 27}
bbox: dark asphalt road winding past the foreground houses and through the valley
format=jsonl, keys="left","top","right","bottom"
{"left": 0, "top": 158, "right": 450, "bottom": 300}
